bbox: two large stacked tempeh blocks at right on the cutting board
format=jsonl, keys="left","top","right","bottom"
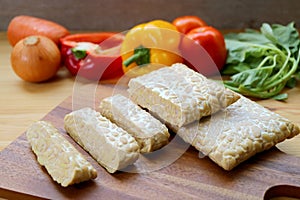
{"left": 128, "top": 64, "right": 299, "bottom": 170}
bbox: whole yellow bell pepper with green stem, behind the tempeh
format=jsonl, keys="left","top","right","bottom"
{"left": 121, "top": 20, "right": 183, "bottom": 77}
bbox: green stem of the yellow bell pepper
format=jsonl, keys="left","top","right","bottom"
{"left": 123, "top": 45, "right": 150, "bottom": 67}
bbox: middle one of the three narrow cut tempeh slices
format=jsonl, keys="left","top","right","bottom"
{"left": 64, "top": 108, "right": 139, "bottom": 173}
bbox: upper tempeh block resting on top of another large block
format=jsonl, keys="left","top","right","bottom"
{"left": 128, "top": 63, "right": 239, "bottom": 127}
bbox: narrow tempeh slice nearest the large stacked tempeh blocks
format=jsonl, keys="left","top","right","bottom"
{"left": 99, "top": 94, "right": 170, "bottom": 153}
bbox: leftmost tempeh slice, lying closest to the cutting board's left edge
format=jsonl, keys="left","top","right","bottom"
{"left": 26, "top": 121, "right": 97, "bottom": 187}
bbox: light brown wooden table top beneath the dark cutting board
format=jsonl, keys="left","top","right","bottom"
{"left": 0, "top": 32, "right": 300, "bottom": 156}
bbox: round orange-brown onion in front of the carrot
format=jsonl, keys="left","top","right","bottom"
{"left": 10, "top": 35, "right": 61, "bottom": 82}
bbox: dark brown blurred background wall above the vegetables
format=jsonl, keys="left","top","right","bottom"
{"left": 0, "top": 0, "right": 300, "bottom": 31}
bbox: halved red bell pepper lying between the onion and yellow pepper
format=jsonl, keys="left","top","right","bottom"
{"left": 60, "top": 32, "right": 124, "bottom": 80}
